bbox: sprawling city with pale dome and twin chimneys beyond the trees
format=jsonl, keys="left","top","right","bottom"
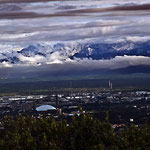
{"left": 0, "top": 80, "right": 150, "bottom": 128}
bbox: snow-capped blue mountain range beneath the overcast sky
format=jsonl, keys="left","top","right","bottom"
{"left": 0, "top": 41, "right": 150, "bottom": 64}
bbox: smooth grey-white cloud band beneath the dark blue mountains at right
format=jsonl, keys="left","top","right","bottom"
{"left": 72, "top": 55, "right": 150, "bottom": 70}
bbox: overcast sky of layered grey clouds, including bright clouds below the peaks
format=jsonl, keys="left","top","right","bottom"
{"left": 0, "top": 0, "right": 150, "bottom": 75}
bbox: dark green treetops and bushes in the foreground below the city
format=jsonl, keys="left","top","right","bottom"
{"left": 0, "top": 110, "right": 150, "bottom": 150}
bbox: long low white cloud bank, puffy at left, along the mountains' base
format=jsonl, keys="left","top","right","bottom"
{"left": 10, "top": 52, "right": 150, "bottom": 70}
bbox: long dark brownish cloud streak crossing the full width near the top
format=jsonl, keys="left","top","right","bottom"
{"left": 0, "top": 0, "right": 150, "bottom": 19}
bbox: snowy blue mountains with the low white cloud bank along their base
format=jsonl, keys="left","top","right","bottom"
{"left": 0, "top": 41, "right": 150, "bottom": 71}
